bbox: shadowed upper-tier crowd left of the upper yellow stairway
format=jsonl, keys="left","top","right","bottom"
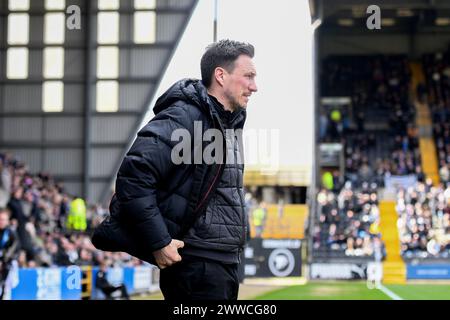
{"left": 319, "top": 56, "right": 423, "bottom": 186}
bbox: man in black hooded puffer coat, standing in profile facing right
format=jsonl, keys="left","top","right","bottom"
{"left": 111, "top": 40, "right": 257, "bottom": 301}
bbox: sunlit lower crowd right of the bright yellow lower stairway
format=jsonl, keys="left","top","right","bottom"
{"left": 396, "top": 180, "right": 450, "bottom": 258}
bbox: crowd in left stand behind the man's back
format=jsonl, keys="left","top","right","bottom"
{"left": 0, "top": 153, "right": 141, "bottom": 267}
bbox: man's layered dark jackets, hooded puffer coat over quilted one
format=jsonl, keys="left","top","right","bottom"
{"left": 111, "top": 79, "right": 246, "bottom": 262}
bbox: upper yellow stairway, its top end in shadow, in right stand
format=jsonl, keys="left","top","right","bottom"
{"left": 410, "top": 62, "right": 439, "bottom": 185}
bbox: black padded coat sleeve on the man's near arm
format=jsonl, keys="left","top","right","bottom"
{"left": 116, "top": 107, "right": 191, "bottom": 252}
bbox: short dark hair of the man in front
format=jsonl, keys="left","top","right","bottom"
{"left": 200, "top": 39, "right": 255, "bottom": 88}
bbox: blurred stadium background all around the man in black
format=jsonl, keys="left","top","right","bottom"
{"left": 0, "top": 0, "right": 450, "bottom": 300}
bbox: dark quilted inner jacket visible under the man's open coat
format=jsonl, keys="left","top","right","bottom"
{"left": 184, "top": 97, "right": 247, "bottom": 263}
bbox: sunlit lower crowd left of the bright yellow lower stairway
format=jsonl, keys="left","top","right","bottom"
{"left": 313, "top": 182, "right": 385, "bottom": 260}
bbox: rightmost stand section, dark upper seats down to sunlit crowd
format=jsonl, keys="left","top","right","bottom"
{"left": 388, "top": 51, "right": 450, "bottom": 260}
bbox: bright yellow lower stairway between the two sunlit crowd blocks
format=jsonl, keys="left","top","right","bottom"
{"left": 380, "top": 201, "right": 406, "bottom": 284}
